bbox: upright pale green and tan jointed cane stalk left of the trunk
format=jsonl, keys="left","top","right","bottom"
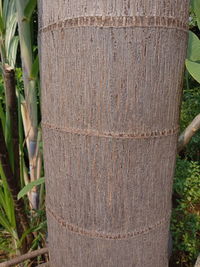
{"left": 16, "top": 0, "right": 38, "bottom": 209}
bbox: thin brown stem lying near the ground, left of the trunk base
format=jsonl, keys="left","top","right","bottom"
{"left": 0, "top": 248, "right": 48, "bottom": 267}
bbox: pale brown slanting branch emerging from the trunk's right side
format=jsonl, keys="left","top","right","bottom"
{"left": 178, "top": 114, "right": 200, "bottom": 153}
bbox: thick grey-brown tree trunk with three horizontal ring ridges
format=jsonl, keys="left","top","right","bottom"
{"left": 39, "top": 0, "right": 189, "bottom": 267}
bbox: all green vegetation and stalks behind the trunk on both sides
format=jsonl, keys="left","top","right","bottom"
{"left": 0, "top": 0, "right": 200, "bottom": 267}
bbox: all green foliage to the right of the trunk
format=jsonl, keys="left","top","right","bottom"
{"left": 171, "top": 3, "right": 200, "bottom": 267}
